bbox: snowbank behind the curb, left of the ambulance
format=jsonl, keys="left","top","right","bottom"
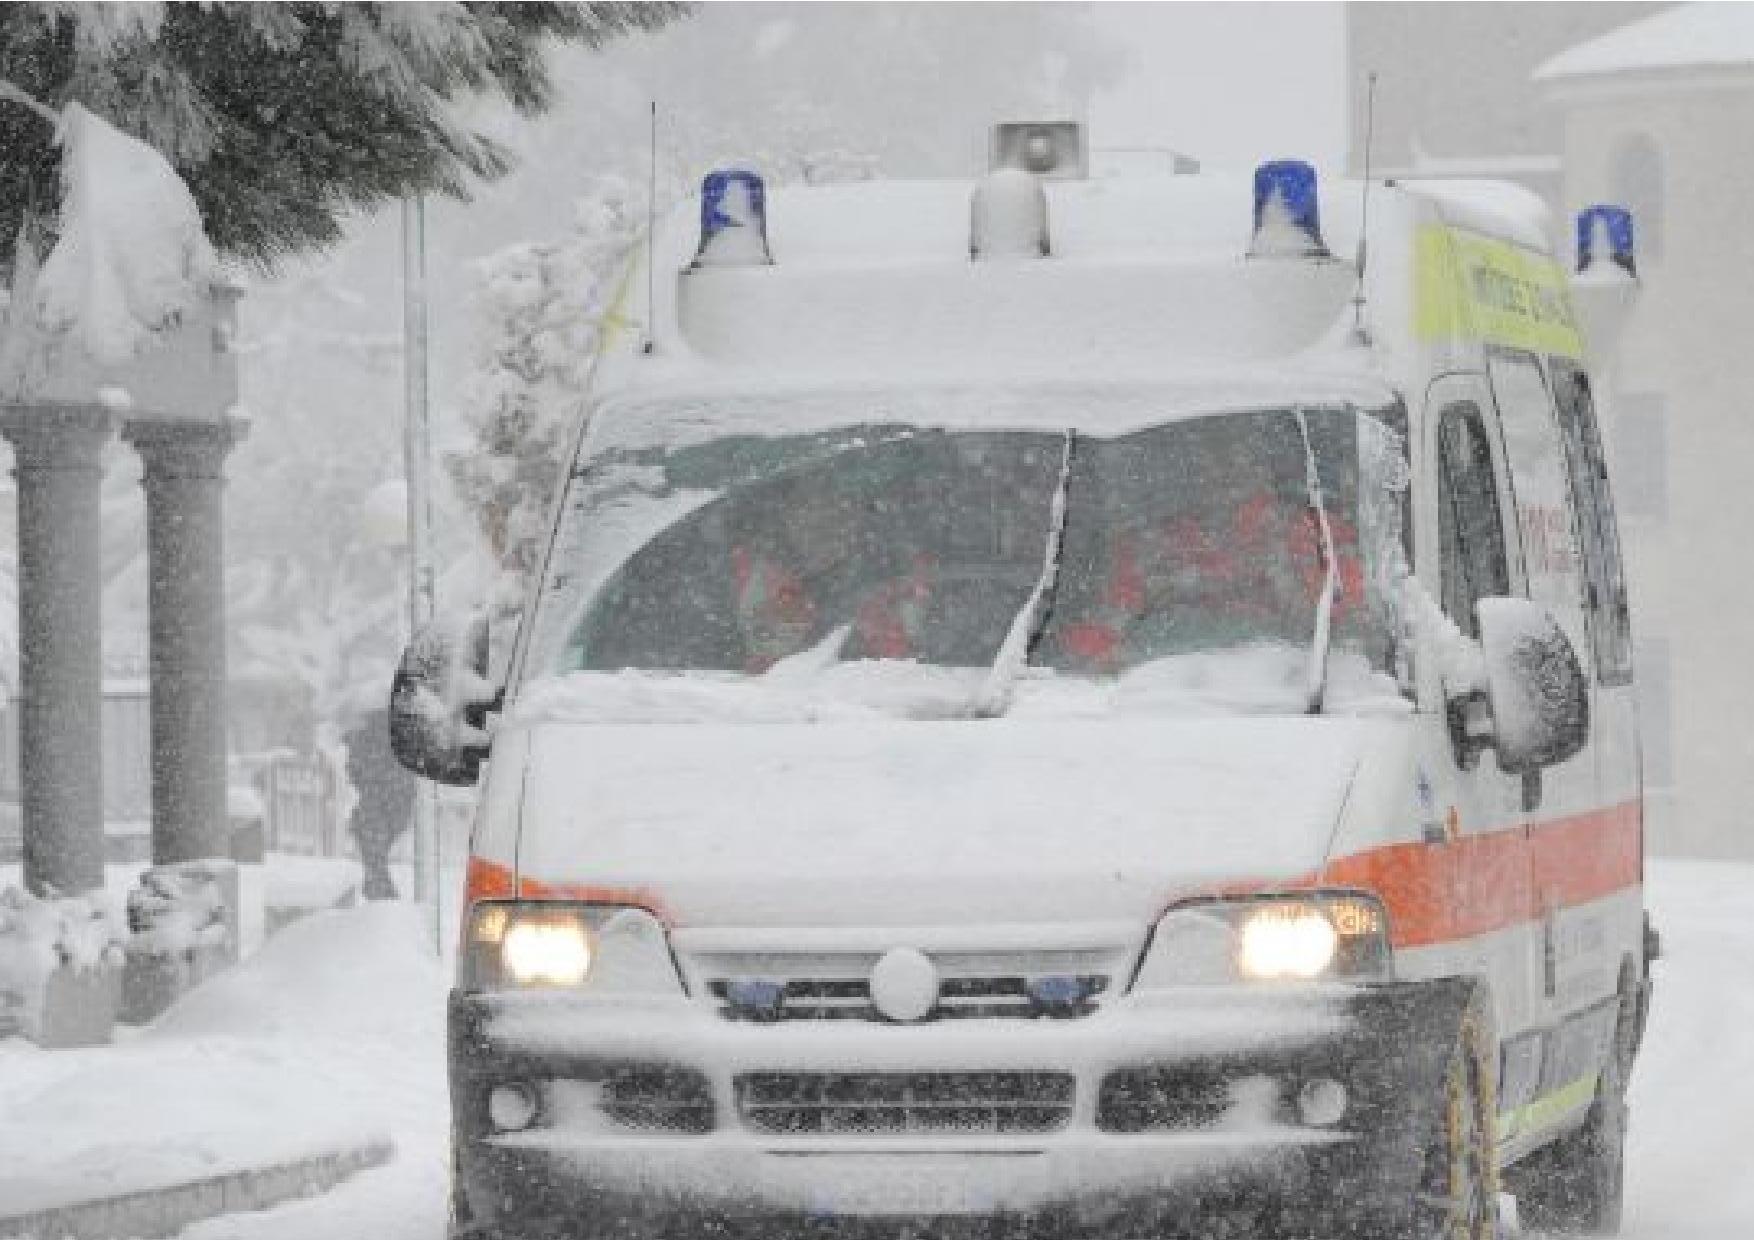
{"left": 0, "top": 903, "right": 447, "bottom": 1235}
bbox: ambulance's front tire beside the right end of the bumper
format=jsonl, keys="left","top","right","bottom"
{"left": 1405, "top": 1001, "right": 1498, "bottom": 1240}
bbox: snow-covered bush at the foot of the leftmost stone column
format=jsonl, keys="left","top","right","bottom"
{"left": 0, "top": 887, "right": 125, "bottom": 1037}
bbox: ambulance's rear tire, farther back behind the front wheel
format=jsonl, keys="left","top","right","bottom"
{"left": 1517, "top": 1054, "right": 1629, "bottom": 1236}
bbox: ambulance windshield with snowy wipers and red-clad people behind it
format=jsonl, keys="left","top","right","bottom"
{"left": 522, "top": 409, "right": 1398, "bottom": 719}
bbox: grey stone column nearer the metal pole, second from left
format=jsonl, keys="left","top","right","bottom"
{"left": 123, "top": 419, "right": 239, "bottom": 865}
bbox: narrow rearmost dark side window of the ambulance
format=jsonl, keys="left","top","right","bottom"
{"left": 1551, "top": 358, "right": 1633, "bottom": 681}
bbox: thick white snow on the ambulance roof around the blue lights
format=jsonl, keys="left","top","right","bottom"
{"left": 613, "top": 175, "right": 1382, "bottom": 393}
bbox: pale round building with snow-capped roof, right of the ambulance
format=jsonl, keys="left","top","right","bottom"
{"left": 1535, "top": 4, "right": 1754, "bottom": 858}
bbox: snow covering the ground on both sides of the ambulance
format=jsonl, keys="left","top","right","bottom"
{"left": 0, "top": 861, "right": 1754, "bottom": 1240}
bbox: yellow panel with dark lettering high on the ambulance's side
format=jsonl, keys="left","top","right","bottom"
{"left": 1414, "top": 224, "right": 1584, "bottom": 358}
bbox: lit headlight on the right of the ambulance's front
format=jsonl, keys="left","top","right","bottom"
{"left": 1133, "top": 891, "right": 1393, "bottom": 989}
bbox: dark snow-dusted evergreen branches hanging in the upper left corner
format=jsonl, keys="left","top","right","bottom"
{"left": 0, "top": 2, "right": 679, "bottom": 263}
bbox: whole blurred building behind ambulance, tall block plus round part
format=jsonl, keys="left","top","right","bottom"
{"left": 1347, "top": 4, "right": 1754, "bottom": 858}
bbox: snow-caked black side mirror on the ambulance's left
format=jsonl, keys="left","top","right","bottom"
{"left": 389, "top": 616, "right": 500, "bottom": 786}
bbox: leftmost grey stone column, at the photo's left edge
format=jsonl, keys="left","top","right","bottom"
{"left": 0, "top": 405, "right": 112, "bottom": 896}
